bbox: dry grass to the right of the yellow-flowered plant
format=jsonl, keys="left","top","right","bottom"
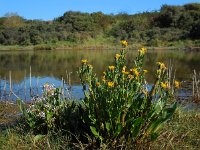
{"left": 149, "top": 108, "right": 200, "bottom": 150}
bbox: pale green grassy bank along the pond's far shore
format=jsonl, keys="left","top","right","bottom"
{"left": 0, "top": 36, "right": 200, "bottom": 51}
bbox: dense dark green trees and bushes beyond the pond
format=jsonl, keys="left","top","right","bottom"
{"left": 0, "top": 3, "right": 200, "bottom": 46}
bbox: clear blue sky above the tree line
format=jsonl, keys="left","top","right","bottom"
{"left": 0, "top": 0, "right": 200, "bottom": 20}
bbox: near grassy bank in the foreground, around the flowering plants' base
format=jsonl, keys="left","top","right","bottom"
{"left": 0, "top": 107, "right": 200, "bottom": 150}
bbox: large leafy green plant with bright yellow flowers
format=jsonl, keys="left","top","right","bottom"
{"left": 79, "top": 41, "right": 179, "bottom": 148}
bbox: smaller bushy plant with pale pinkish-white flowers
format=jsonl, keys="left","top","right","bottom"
{"left": 17, "top": 83, "right": 80, "bottom": 133}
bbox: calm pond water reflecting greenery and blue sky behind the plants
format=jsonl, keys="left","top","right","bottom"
{"left": 0, "top": 49, "right": 200, "bottom": 100}
